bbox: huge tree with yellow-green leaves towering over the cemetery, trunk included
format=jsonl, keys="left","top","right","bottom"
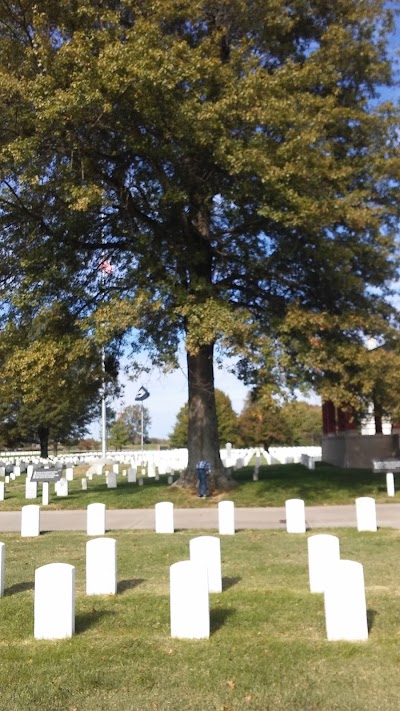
{"left": 0, "top": 0, "right": 399, "bottom": 486}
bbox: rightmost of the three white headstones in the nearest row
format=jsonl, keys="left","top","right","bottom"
{"left": 324, "top": 560, "right": 368, "bottom": 642}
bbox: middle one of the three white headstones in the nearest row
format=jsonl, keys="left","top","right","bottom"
{"left": 170, "top": 560, "right": 210, "bottom": 639}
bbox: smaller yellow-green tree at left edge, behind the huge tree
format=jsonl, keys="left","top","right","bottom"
{"left": 0, "top": 303, "right": 118, "bottom": 457}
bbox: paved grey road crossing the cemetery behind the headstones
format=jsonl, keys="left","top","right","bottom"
{"left": 0, "top": 504, "right": 400, "bottom": 532}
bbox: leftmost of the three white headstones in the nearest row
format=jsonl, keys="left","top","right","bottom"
{"left": 34, "top": 563, "right": 75, "bottom": 639}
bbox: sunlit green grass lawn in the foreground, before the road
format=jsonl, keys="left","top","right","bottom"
{"left": 0, "top": 529, "right": 400, "bottom": 711}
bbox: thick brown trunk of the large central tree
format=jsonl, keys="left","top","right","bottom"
{"left": 177, "top": 345, "right": 234, "bottom": 492}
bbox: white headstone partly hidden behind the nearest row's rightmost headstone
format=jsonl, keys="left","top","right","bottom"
{"left": 307, "top": 533, "right": 340, "bottom": 593}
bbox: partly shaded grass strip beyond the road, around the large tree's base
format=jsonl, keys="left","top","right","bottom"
{"left": 0, "top": 464, "right": 396, "bottom": 511}
